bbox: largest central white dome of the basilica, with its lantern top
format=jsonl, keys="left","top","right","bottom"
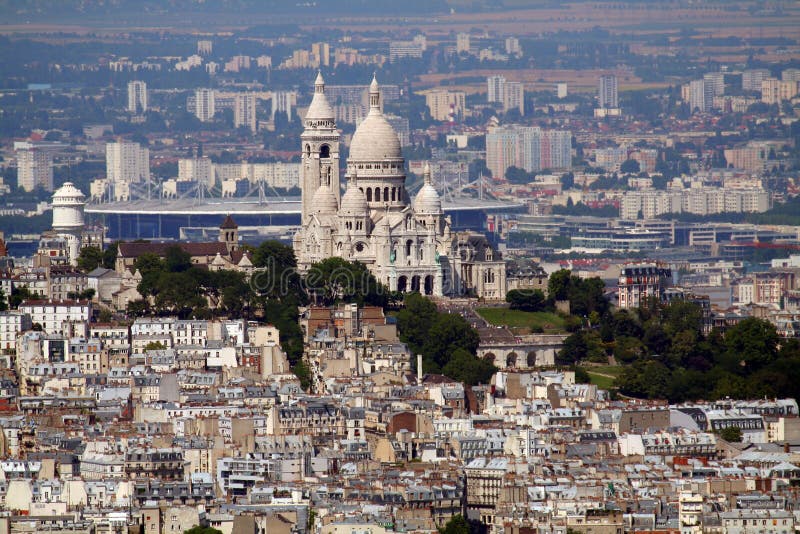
{"left": 350, "top": 78, "right": 403, "bottom": 161}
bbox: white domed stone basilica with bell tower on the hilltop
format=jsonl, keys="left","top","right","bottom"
{"left": 294, "top": 74, "right": 506, "bottom": 299}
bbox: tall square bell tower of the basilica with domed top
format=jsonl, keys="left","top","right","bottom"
{"left": 300, "top": 72, "right": 340, "bottom": 224}
